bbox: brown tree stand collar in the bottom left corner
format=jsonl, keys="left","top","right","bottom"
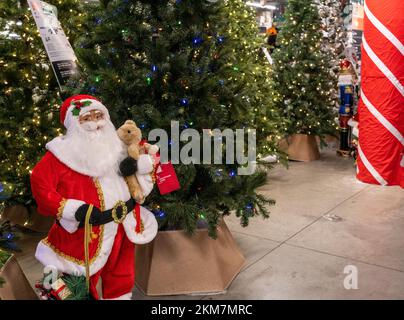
{"left": 0, "top": 255, "right": 38, "bottom": 300}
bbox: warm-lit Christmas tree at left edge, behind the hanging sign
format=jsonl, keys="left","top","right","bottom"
{"left": 0, "top": 0, "right": 84, "bottom": 205}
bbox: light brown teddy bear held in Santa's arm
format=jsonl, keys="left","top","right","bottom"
{"left": 117, "top": 120, "right": 159, "bottom": 204}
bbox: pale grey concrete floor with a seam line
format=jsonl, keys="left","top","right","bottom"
{"left": 14, "top": 150, "right": 404, "bottom": 299}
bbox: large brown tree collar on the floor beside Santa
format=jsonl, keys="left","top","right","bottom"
{"left": 135, "top": 221, "right": 245, "bottom": 296}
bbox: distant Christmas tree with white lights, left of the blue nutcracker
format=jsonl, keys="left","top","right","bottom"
{"left": 273, "top": 0, "right": 337, "bottom": 136}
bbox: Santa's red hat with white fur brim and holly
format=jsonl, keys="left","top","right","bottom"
{"left": 60, "top": 94, "right": 109, "bottom": 129}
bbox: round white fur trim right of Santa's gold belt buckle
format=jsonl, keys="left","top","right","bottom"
{"left": 123, "top": 207, "right": 158, "bottom": 244}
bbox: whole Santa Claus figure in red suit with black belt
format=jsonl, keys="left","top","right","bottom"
{"left": 31, "top": 95, "right": 157, "bottom": 299}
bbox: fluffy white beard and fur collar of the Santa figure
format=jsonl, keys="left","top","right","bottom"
{"left": 46, "top": 119, "right": 126, "bottom": 177}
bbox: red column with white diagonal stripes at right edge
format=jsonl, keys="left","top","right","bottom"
{"left": 357, "top": 0, "right": 404, "bottom": 188}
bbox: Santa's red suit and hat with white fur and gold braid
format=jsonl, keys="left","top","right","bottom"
{"left": 31, "top": 95, "right": 157, "bottom": 299}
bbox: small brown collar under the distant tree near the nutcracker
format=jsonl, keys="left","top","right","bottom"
{"left": 279, "top": 133, "right": 320, "bottom": 161}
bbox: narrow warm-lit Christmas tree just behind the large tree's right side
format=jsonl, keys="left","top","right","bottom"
{"left": 217, "top": 0, "right": 287, "bottom": 160}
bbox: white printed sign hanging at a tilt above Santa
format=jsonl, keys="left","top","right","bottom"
{"left": 28, "top": 0, "right": 78, "bottom": 86}
